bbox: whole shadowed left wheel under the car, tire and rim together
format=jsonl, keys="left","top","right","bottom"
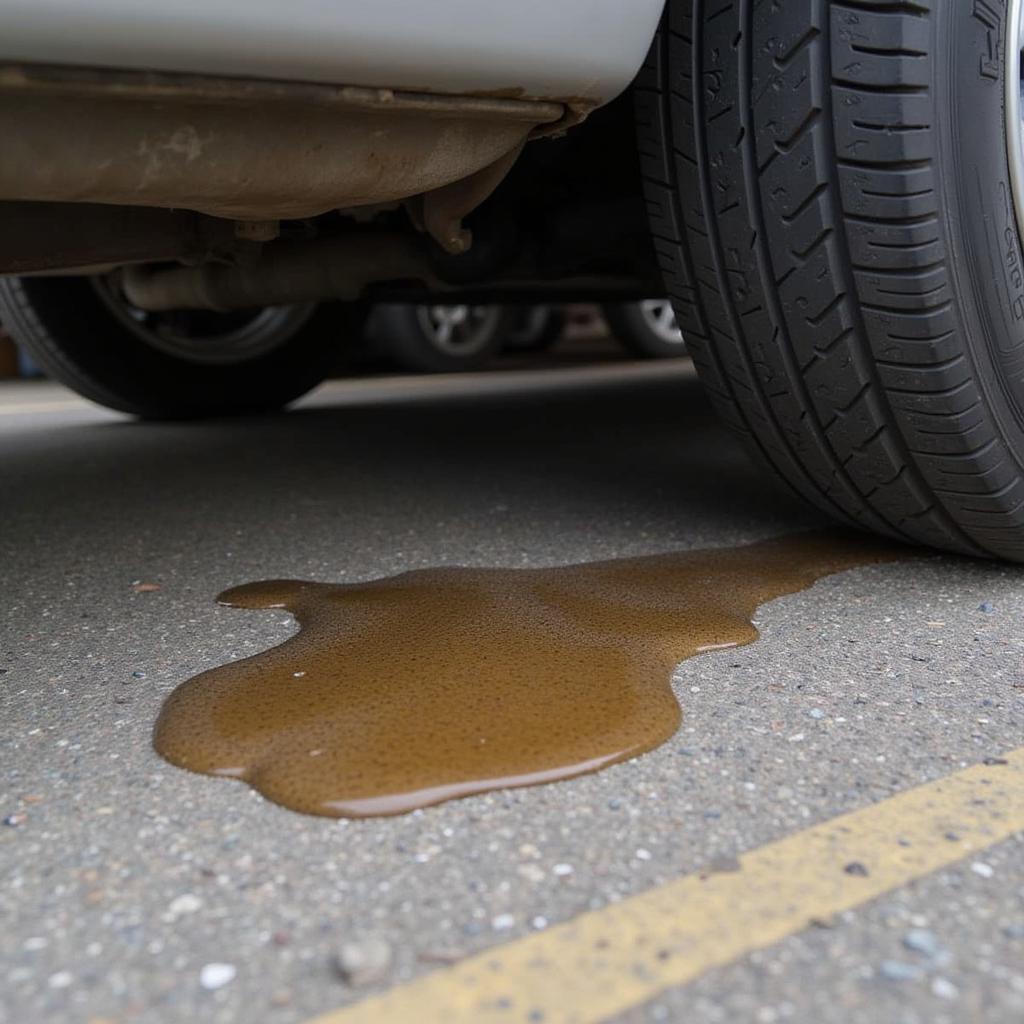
{"left": 0, "top": 278, "right": 351, "bottom": 419}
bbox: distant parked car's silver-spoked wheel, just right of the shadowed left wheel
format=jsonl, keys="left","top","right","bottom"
{"left": 374, "top": 304, "right": 514, "bottom": 374}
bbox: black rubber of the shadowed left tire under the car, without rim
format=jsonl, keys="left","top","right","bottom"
{"left": 0, "top": 278, "right": 352, "bottom": 419}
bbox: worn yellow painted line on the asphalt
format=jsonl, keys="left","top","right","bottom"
{"left": 309, "top": 749, "right": 1024, "bottom": 1024}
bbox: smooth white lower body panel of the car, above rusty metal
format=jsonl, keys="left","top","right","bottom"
{"left": 0, "top": 0, "right": 664, "bottom": 101}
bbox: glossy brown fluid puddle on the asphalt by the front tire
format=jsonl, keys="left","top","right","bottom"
{"left": 154, "top": 534, "right": 910, "bottom": 817}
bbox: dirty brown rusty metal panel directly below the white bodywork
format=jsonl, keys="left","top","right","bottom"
{"left": 0, "top": 65, "right": 565, "bottom": 218}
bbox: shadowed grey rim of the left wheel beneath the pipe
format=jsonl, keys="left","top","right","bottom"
{"left": 93, "top": 274, "right": 315, "bottom": 366}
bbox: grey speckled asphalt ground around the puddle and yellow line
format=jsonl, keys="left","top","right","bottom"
{"left": 0, "top": 362, "right": 1024, "bottom": 1024}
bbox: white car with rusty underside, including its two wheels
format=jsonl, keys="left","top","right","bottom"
{"left": 0, "top": 0, "right": 1024, "bottom": 559}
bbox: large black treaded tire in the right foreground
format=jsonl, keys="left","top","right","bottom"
{"left": 636, "top": 0, "right": 1024, "bottom": 560}
